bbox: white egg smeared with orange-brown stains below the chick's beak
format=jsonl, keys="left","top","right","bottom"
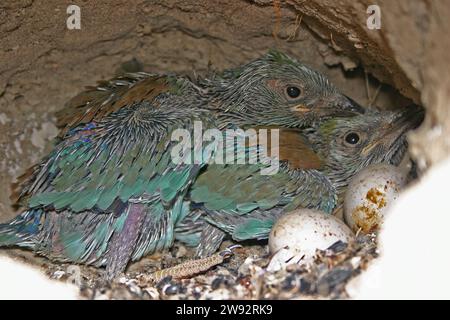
{"left": 344, "top": 163, "right": 407, "bottom": 234}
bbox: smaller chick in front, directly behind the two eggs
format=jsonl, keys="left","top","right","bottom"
{"left": 185, "top": 107, "right": 423, "bottom": 256}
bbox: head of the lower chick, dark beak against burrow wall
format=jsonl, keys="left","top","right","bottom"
{"left": 305, "top": 106, "right": 424, "bottom": 194}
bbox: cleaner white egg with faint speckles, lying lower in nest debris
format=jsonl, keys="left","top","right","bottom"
{"left": 268, "top": 209, "right": 354, "bottom": 271}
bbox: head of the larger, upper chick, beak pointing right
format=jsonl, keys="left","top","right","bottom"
{"left": 204, "top": 50, "right": 364, "bottom": 128}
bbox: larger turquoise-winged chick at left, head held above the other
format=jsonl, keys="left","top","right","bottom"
{"left": 0, "top": 51, "right": 362, "bottom": 279}
